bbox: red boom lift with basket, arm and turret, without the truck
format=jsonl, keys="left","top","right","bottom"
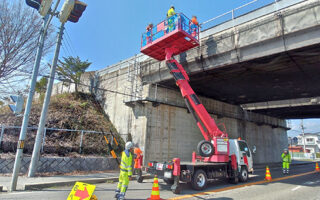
{"left": 141, "top": 13, "right": 229, "bottom": 163}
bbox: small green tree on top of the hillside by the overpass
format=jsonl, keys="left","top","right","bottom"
{"left": 57, "top": 56, "right": 91, "bottom": 93}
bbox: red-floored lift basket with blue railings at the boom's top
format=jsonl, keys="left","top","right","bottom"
{"left": 141, "top": 13, "right": 199, "bottom": 61}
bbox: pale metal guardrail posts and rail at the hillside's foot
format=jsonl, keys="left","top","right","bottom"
{"left": 0, "top": 125, "right": 126, "bottom": 153}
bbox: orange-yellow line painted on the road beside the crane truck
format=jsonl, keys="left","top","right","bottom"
{"left": 168, "top": 171, "right": 317, "bottom": 200}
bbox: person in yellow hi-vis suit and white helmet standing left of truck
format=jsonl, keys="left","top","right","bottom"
{"left": 115, "top": 142, "right": 133, "bottom": 200}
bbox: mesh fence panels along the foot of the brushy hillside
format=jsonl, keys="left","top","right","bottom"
{"left": 0, "top": 125, "right": 124, "bottom": 156}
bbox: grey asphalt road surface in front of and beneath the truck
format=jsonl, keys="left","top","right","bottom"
{"left": 0, "top": 164, "right": 320, "bottom": 200}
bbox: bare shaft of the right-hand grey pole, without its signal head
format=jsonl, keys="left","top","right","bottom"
{"left": 28, "top": 23, "right": 64, "bottom": 177}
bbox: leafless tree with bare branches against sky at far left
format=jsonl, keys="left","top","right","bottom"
{"left": 0, "top": 0, "right": 54, "bottom": 98}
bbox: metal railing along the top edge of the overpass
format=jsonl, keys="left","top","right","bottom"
{"left": 200, "top": 0, "right": 306, "bottom": 31}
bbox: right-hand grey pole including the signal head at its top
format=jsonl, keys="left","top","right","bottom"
{"left": 28, "top": 0, "right": 87, "bottom": 177}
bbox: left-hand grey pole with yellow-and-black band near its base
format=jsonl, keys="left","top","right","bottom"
{"left": 9, "top": 0, "right": 60, "bottom": 191}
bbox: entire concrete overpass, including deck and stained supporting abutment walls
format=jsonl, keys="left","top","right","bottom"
{"left": 54, "top": 0, "right": 320, "bottom": 163}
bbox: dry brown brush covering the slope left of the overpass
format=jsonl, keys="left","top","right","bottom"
{"left": 0, "top": 93, "right": 124, "bottom": 156}
